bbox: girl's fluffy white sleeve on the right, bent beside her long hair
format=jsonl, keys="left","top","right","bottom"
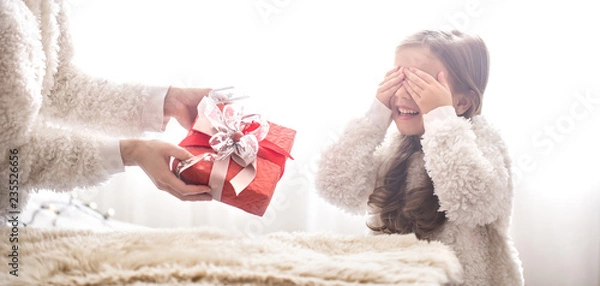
{"left": 422, "top": 106, "right": 512, "bottom": 227}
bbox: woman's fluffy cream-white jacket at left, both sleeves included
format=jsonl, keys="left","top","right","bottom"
{"left": 0, "top": 0, "right": 166, "bottom": 225}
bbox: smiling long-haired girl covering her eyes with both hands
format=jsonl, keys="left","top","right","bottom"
{"left": 316, "top": 31, "right": 524, "bottom": 285}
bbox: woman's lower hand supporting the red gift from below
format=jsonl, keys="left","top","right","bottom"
{"left": 120, "top": 139, "right": 212, "bottom": 201}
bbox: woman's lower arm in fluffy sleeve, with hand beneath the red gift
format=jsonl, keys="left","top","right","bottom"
{"left": 0, "top": 117, "right": 211, "bottom": 222}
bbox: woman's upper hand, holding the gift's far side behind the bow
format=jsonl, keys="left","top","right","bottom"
{"left": 164, "top": 87, "right": 211, "bottom": 130}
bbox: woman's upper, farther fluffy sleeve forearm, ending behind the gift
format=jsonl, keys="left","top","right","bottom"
{"left": 48, "top": 64, "right": 168, "bottom": 136}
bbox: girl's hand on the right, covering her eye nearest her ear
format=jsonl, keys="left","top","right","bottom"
{"left": 404, "top": 67, "right": 452, "bottom": 114}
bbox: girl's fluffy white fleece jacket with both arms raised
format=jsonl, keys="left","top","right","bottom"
{"left": 316, "top": 100, "right": 524, "bottom": 285}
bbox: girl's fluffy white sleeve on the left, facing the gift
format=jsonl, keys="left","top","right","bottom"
{"left": 315, "top": 100, "right": 391, "bottom": 214}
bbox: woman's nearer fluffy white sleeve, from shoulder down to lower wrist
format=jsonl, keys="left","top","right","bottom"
{"left": 0, "top": 1, "right": 108, "bottom": 221}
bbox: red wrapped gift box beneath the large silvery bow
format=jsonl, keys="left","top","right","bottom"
{"left": 173, "top": 97, "right": 296, "bottom": 216}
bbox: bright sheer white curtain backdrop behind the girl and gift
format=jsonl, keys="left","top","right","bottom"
{"left": 64, "top": 0, "right": 600, "bottom": 285}
